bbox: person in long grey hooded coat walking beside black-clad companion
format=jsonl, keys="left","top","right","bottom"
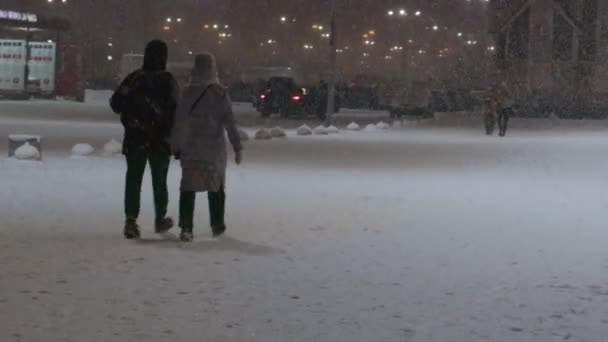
{"left": 172, "top": 54, "right": 242, "bottom": 242}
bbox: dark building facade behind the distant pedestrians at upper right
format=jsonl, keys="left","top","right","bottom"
{"left": 489, "top": 0, "right": 608, "bottom": 116}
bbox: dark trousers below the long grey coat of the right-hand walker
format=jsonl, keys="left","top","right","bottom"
{"left": 179, "top": 188, "right": 226, "bottom": 229}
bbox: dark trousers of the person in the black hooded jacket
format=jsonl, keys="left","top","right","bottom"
{"left": 125, "top": 147, "right": 171, "bottom": 220}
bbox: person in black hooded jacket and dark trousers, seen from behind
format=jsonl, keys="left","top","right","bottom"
{"left": 110, "top": 40, "right": 178, "bottom": 239}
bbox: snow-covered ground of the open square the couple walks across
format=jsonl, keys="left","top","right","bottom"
{"left": 0, "top": 97, "right": 608, "bottom": 342}
